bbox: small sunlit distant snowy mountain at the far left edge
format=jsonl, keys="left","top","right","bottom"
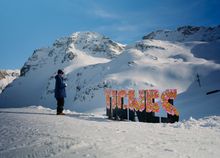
{"left": 0, "top": 70, "right": 20, "bottom": 93}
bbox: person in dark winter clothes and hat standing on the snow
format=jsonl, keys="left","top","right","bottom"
{"left": 55, "top": 70, "right": 67, "bottom": 115}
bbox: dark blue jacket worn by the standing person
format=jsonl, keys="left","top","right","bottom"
{"left": 55, "top": 75, "right": 66, "bottom": 98}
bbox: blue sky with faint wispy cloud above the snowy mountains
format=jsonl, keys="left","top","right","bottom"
{"left": 0, "top": 0, "right": 220, "bottom": 69}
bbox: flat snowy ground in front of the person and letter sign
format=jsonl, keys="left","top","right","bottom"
{"left": 0, "top": 106, "right": 220, "bottom": 158}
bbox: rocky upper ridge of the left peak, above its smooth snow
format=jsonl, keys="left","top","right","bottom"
{"left": 21, "top": 32, "right": 125, "bottom": 76}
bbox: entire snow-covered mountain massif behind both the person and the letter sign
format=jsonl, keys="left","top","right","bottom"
{"left": 0, "top": 26, "right": 220, "bottom": 118}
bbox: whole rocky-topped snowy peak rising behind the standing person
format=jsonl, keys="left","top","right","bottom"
{"left": 0, "top": 32, "right": 125, "bottom": 109}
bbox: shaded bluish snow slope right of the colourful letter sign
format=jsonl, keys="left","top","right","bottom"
{"left": 176, "top": 70, "right": 220, "bottom": 118}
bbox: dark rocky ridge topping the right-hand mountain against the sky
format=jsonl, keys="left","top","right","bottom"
{"left": 143, "top": 25, "right": 220, "bottom": 42}
